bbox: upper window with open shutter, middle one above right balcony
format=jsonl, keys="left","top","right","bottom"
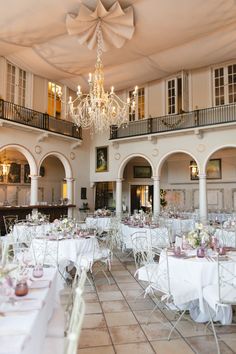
{"left": 166, "top": 71, "right": 189, "bottom": 114}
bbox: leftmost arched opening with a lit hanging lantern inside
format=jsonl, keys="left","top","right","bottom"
{"left": 0, "top": 145, "right": 36, "bottom": 206}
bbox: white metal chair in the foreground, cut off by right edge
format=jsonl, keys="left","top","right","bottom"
{"left": 203, "top": 256, "right": 236, "bottom": 354}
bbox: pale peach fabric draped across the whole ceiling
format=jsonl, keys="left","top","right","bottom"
{"left": 0, "top": 0, "right": 236, "bottom": 91}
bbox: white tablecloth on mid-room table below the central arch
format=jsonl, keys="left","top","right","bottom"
{"left": 121, "top": 224, "right": 169, "bottom": 249}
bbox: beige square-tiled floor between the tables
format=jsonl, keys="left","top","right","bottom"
{"left": 78, "top": 253, "right": 236, "bottom": 354}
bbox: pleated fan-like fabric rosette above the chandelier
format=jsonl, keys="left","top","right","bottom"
{"left": 66, "top": 0, "right": 134, "bottom": 51}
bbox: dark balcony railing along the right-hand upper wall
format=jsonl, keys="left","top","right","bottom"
{"left": 110, "top": 104, "right": 236, "bottom": 140}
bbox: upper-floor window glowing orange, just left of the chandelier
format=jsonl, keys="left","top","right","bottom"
{"left": 48, "top": 81, "right": 62, "bottom": 118}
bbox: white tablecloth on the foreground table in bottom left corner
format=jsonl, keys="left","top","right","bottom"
{"left": 0, "top": 268, "right": 57, "bottom": 354}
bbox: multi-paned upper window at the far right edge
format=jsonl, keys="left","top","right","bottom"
{"left": 213, "top": 64, "right": 236, "bottom": 106}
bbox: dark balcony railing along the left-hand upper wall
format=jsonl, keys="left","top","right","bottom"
{"left": 0, "top": 99, "right": 82, "bottom": 139}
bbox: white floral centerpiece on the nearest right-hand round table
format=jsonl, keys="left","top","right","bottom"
{"left": 187, "top": 223, "right": 211, "bottom": 248}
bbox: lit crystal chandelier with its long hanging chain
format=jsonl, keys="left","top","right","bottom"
{"left": 68, "top": 21, "right": 138, "bottom": 133}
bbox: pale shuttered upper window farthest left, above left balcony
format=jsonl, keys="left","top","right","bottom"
{"left": 6, "top": 63, "right": 27, "bottom": 107}
